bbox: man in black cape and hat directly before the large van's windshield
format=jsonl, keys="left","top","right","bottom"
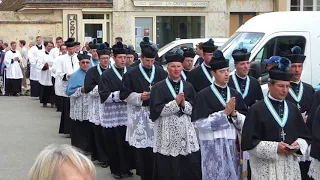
{"left": 228, "top": 49, "right": 263, "bottom": 108}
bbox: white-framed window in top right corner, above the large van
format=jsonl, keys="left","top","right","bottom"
{"left": 290, "top": 0, "right": 320, "bottom": 11}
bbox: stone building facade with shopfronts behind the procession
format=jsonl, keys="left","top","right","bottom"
{"left": 0, "top": 0, "right": 287, "bottom": 48}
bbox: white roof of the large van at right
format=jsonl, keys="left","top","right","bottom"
{"left": 236, "top": 11, "right": 320, "bottom": 34}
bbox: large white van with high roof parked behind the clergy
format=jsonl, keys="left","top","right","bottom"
{"left": 221, "top": 11, "right": 320, "bottom": 93}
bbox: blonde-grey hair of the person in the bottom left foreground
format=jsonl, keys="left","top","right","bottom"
{"left": 29, "top": 144, "right": 96, "bottom": 180}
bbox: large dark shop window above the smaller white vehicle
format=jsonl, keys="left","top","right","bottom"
{"left": 156, "top": 16, "right": 205, "bottom": 48}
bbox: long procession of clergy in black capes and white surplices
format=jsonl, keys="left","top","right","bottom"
{"left": 5, "top": 34, "right": 320, "bottom": 180}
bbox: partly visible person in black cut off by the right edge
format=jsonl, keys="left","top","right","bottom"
{"left": 308, "top": 105, "right": 320, "bottom": 180}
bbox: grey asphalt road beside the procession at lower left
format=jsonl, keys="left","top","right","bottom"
{"left": 0, "top": 96, "right": 140, "bottom": 180}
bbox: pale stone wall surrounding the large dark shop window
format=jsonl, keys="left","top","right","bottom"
{"left": 112, "top": 0, "right": 273, "bottom": 43}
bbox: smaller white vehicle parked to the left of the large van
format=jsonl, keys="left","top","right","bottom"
{"left": 158, "top": 38, "right": 228, "bottom": 63}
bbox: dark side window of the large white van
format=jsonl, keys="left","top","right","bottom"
{"left": 253, "top": 36, "right": 306, "bottom": 84}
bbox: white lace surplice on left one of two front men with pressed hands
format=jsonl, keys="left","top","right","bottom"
{"left": 153, "top": 100, "right": 199, "bottom": 157}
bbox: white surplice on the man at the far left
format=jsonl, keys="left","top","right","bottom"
{"left": 4, "top": 51, "right": 23, "bottom": 79}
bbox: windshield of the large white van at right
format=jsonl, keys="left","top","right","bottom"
{"left": 221, "top": 32, "right": 264, "bottom": 71}
